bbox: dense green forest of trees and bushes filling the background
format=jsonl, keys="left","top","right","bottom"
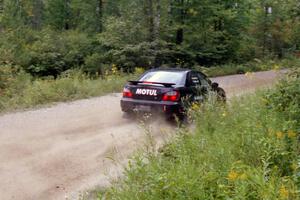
{"left": 0, "top": 0, "right": 300, "bottom": 78}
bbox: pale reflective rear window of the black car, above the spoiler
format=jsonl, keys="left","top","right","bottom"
{"left": 140, "top": 71, "right": 185, "bottom": 85}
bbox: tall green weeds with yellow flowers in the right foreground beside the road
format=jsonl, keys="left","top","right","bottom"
{"left": 98, "top": 69, "right": 300, "bottom": 200}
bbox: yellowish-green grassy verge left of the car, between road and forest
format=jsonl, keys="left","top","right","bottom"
{"left": 0, "top": 66, "right": 136, "bottom": 112}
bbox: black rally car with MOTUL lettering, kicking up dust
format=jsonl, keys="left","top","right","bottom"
{"left": 121, "top": 68, "right": 226, "bottom": 118}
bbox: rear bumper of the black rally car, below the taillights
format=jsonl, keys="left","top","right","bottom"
{"left": 120, "top": 98, "right": 184, "bottom": 117}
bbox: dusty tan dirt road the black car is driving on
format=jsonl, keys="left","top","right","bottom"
{"left": 0, "top": 71, "right": 286, "bottom": 200}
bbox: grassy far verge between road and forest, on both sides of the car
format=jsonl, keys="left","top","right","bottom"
{"left": 0, "top": 58, "right": 300, "bottom": 113}
